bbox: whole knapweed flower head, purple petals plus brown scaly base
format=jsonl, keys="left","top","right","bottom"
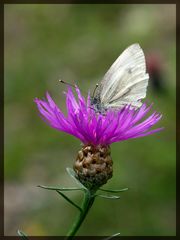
{"left": 35, "top": 86, "right": 162, "bottom": 189}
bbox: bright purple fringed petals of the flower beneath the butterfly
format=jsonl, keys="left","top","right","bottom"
{"left": 35, "top": 87, "right": 162, "bottom": 146}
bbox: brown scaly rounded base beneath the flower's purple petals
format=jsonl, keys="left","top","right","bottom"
{"left": 74, "top": 145, "right": 113, "bottom": 189}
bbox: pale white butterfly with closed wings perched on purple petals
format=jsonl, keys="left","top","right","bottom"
{"left": 91, "top": 43, "right": 149, "bottom": 112}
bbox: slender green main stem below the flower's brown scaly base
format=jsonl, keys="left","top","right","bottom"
{"left": 66, "top": 190, "right": 95, "bottom": 240}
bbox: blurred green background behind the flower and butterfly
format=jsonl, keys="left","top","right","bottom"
{"left": 5, "top": 4, "right": 176, "bottom": 236}
